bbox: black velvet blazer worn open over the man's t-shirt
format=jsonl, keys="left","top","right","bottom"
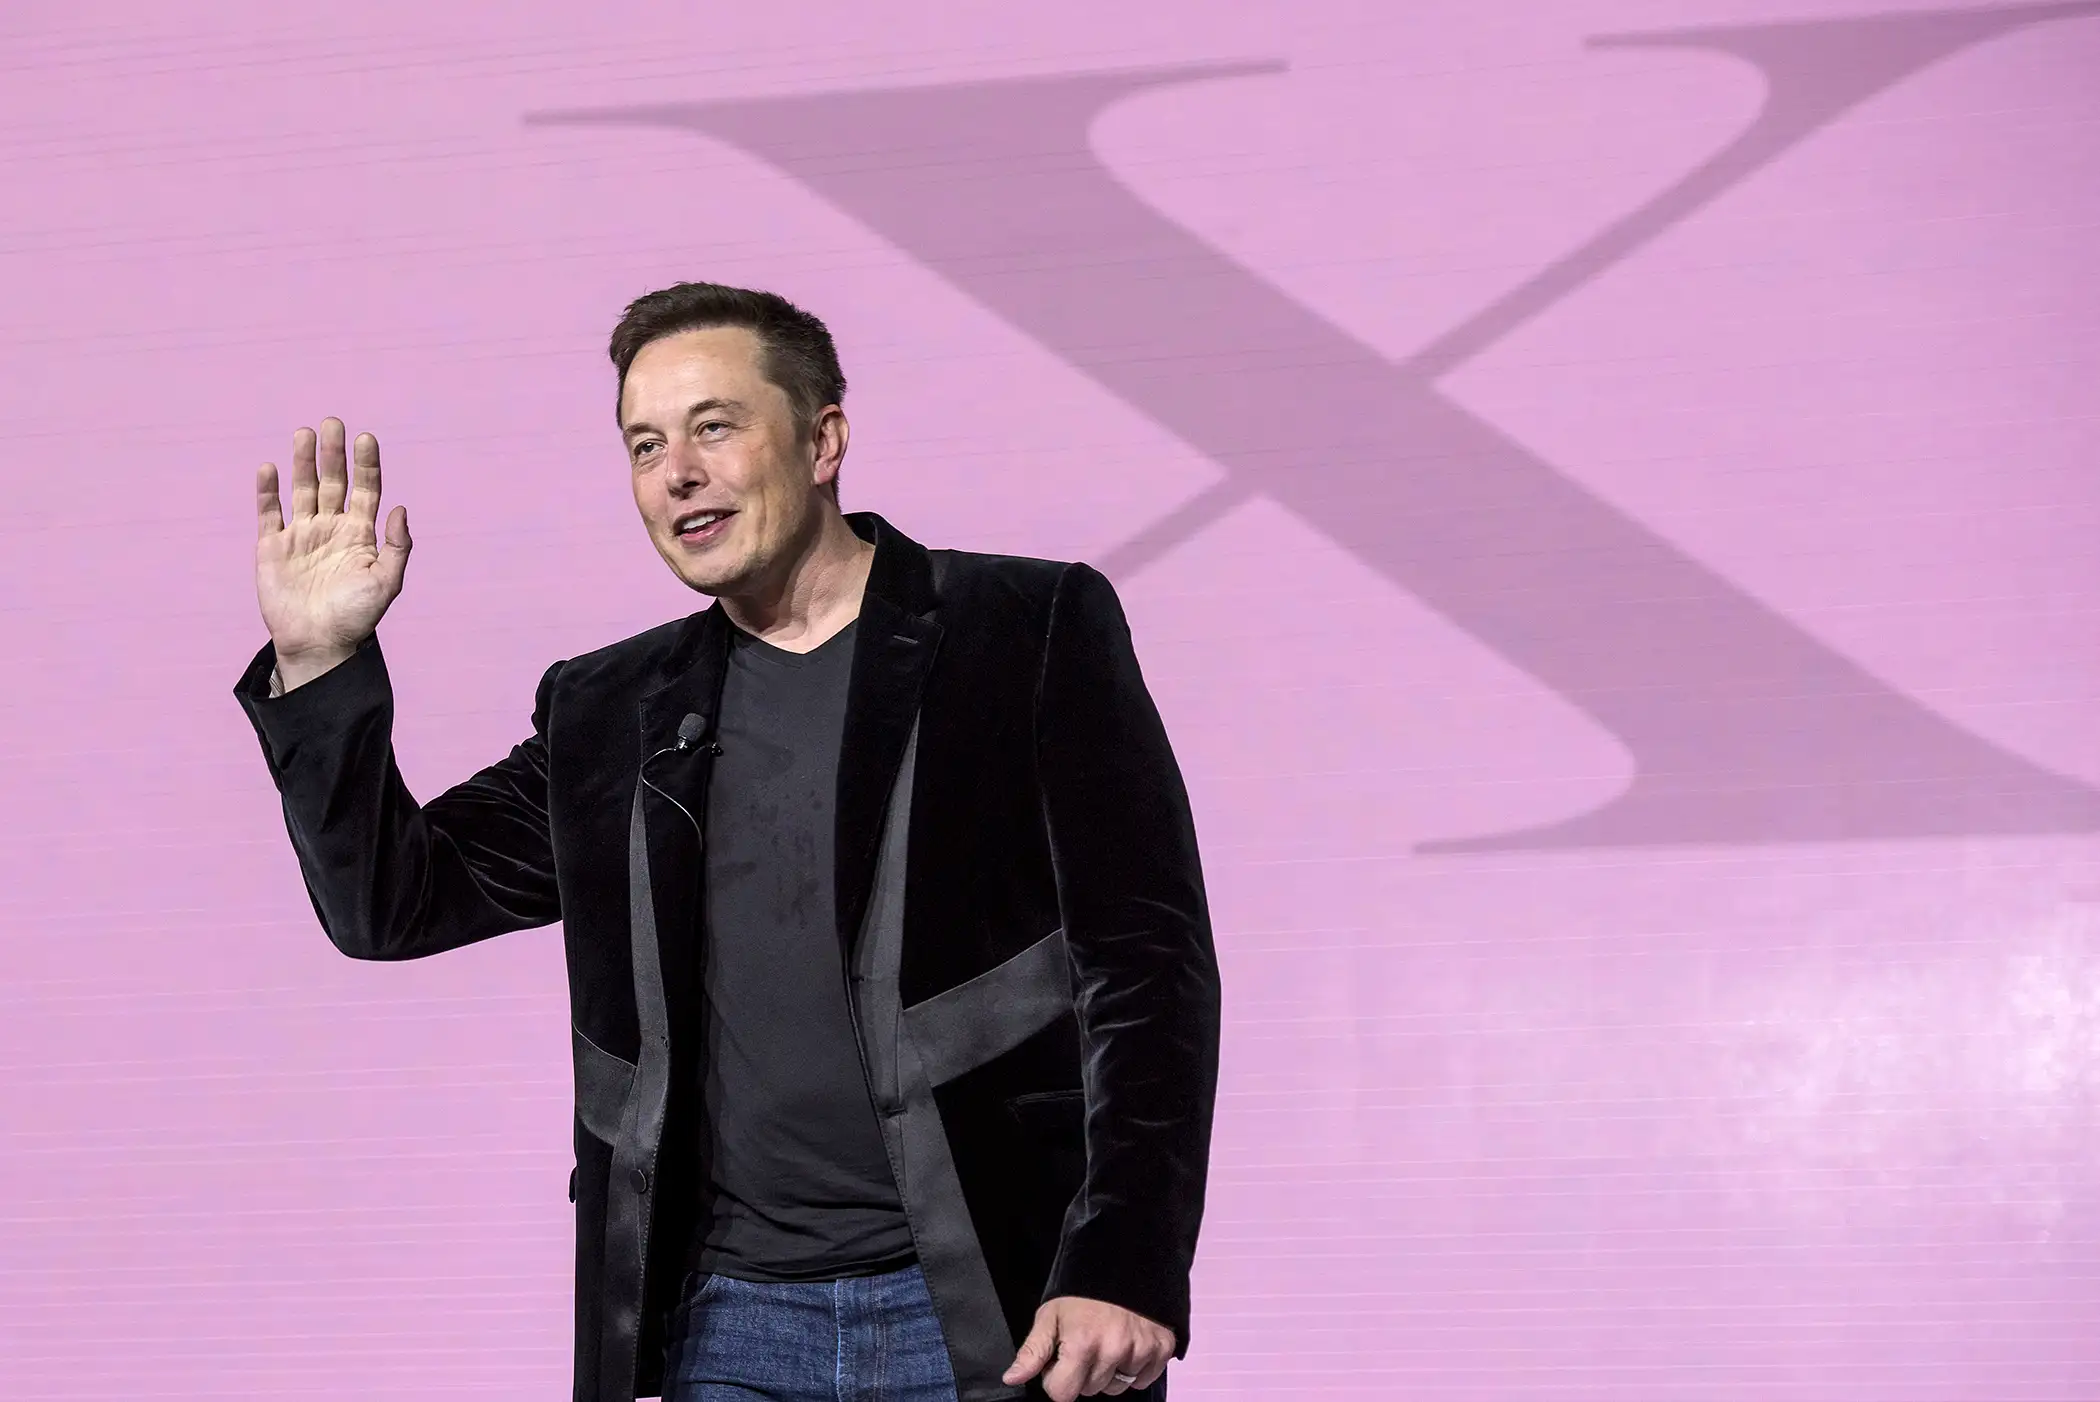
{"left": 235, "top": 514, "right": 1218, "bottom": 1402}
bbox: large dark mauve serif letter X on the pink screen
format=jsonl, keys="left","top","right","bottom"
{"left": 533, "top": 2, "right": 2100, "bottom": 850}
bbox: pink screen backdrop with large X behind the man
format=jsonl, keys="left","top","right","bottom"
{"left": 0, "top": 0, "right": 2100, "bottom": 1402}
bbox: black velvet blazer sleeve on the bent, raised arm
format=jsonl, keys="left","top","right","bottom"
{"left": 233, "top": 640, "right": 561, "bottom": 959}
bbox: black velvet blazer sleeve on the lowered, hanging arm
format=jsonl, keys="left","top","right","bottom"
{"left": 1037, "top": 565, "right": 1220, "bottom": 1356}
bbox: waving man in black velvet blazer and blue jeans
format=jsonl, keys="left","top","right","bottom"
{"left": 237, "top": 283, "right": 1218, "bottom": 1402}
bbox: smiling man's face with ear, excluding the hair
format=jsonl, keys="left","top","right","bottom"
{"left": 620, "top": 325, "right": 844, "bottom": 594}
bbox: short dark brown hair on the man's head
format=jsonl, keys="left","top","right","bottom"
{"left": 609, "top": 283, "right": 846, "bottom": 432}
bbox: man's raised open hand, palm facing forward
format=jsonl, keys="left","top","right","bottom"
{"left": 256, "top": 418, "right": 410, "bottom": 691}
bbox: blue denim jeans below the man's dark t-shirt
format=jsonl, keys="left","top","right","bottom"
{"left": 664, "top": 1266, "right": 956, "bottom": 1402}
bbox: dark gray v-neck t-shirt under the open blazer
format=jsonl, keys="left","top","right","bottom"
{"left": 693, "top": 623, "right": 914, "bottom": 1280}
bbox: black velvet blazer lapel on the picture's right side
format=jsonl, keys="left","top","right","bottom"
{"left": 834, "top": 512, "right": 941, "bottom": 955}
